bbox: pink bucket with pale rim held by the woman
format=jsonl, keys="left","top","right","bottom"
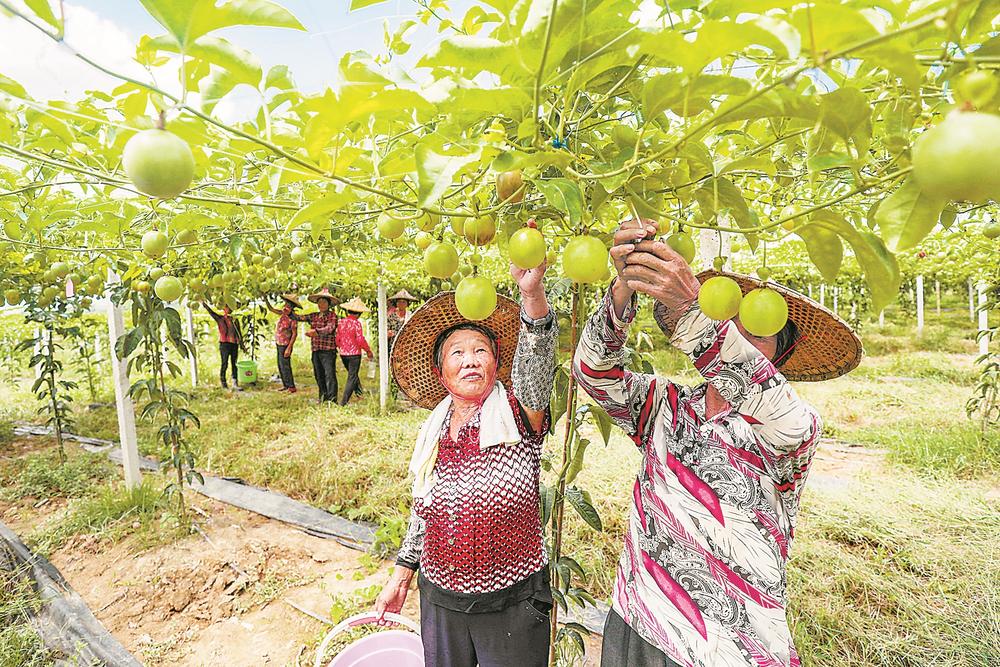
{"left": 316, "top": 612, "right": 424, "bottom": 667}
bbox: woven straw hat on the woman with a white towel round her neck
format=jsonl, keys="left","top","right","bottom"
{"left": 391, "top": 292, "right": 521, "bottom": 409}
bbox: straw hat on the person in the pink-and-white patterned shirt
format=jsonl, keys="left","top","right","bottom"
{"left": 698, "top": 271, "right": 864, "bottom": 382}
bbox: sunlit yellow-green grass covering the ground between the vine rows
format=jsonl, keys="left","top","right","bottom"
{"left": 0, "top": 294, "right": 1000, "bottom": 667}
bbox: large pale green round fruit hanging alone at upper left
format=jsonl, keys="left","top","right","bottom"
{"left": 122, "top": 130, "right": 194, "bottom": 199}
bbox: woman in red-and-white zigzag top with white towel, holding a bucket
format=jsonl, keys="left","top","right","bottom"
{"left": 376, "top": 265, "right": 558, "bottom": 667}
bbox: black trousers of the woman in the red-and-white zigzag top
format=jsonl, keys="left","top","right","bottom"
{"left": 420, "top": 597, "right": 549, "bottom": 667}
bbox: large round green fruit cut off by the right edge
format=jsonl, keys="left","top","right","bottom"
{"left": 913, "top": 112, "right": 1000, "bottom": 202}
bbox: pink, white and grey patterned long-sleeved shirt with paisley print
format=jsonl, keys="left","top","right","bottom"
{"left": 573, "top": 291, "right": 821, "bottom": 667}
